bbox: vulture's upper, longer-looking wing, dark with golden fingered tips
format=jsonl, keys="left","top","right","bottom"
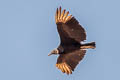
{"left": 55, "top": 7, "right": 86, "bottom": 44}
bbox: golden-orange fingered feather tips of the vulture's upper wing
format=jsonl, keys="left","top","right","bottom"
{"left": 55, "top": 6, "right": 72, "bottom": 23}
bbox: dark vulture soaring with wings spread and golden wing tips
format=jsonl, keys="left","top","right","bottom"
{"left": 48, "top": 7, "right": 95, "bottom": 75}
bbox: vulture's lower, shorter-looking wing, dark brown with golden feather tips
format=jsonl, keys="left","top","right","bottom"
{"left": 56, "top": 50, "right": 86, "bottom": 74}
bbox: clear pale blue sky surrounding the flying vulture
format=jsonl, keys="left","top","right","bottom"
{"left": 0, "top": 0, "right": 120, "bottom": 80}
